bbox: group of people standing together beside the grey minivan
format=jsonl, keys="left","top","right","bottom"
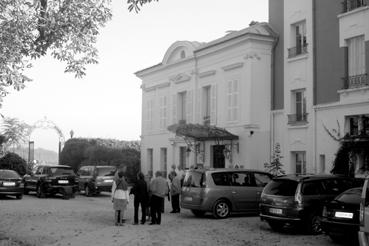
{"left": 111, "top": 166, "right": 184, "bottom": 226}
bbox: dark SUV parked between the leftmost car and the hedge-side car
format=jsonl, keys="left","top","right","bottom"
{"left": 23, "top": 165, "right": 78, "bottom": 199}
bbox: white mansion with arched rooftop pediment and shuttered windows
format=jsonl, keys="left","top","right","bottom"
{"left": 136, "top": 23, "right": 276, "bottom": 176}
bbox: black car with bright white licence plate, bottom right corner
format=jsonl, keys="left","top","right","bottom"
{"left": 321, "top": 187, "right": 362, "bottom": 242}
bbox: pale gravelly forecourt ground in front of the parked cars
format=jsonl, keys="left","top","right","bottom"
{"left": 0, "top": 193, "right": 344, "bottom": 246}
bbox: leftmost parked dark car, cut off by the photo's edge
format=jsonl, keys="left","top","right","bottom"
{"left": 0, "top": 169, "right": 23, "bottom": 199}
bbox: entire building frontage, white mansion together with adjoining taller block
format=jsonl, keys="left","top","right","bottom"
{"left": 136, "top": 0, "right": 369, "bottom": 177}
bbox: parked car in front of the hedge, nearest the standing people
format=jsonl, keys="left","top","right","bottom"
{"left": 78, "top": 166, "right": 117, "bottom": 196}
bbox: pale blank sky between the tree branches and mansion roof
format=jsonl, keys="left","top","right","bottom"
{"left": 0, "top": 0, "right": 268, "bottom": 151}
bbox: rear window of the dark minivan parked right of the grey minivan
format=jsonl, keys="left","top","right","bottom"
{"left": 264, "top": 179, "right": 298, "bottom": 196}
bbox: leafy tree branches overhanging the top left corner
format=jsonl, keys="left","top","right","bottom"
{"left": 0, "top": 0, "right": 112, "bottom": 103}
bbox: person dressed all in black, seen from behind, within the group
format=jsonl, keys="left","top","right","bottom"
{"left": 130, "top": 172, "right": 149, "bottom": 225}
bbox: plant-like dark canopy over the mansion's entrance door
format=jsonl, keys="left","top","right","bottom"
{"left": 168, "top": 123, "right": 238, "bottom": 141}
